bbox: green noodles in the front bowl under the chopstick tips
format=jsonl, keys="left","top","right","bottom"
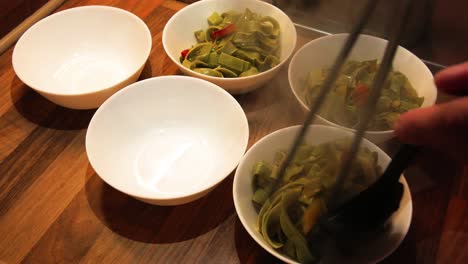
{"left": 252, "top": 139, "right": 381, "bottom": 263}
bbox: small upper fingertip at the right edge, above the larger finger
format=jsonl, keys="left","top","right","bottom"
{"left": 434, "top": 62, "right": 468, "bottom": 95}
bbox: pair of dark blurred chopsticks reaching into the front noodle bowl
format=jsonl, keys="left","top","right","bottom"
{"left": 273, "top": 0, "right": 413, "bottom": 208}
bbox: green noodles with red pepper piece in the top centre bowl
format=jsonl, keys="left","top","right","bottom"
{"left": 180, "top": 9, "right": 280, "bottom": 78}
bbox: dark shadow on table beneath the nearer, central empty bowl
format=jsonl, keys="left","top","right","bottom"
{"left": 85, "top": 165, "right": 234, "bottom": 244}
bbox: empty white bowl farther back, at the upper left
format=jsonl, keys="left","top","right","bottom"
{"left": 13, "top": 6, "right": 151, "bottom": 109}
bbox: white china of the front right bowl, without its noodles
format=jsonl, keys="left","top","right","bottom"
{"left": 233, "top": 125, "right": 413, "bottom": 263}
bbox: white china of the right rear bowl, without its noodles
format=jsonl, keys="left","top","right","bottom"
{"left": 288, "top": 34, "right": 437, "bottom": 143}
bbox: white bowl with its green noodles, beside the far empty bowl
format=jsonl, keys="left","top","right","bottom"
{"left": 162, "top": 0, "right": 296, "bottom": 94}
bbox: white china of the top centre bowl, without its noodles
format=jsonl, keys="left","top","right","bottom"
{"left": 162, "top": 0, "right": 297, "bottom": 94}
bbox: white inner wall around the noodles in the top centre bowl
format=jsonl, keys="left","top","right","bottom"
{"left": 163, "top": 0, "right": 296, "bottom": 71}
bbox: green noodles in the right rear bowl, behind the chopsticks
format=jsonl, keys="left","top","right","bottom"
{"left": 303, "top": 60, "right": 424, "bottom": 131}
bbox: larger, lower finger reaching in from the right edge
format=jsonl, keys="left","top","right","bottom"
{"left": 395, "top": 98, "right": 468, "bottom": 148}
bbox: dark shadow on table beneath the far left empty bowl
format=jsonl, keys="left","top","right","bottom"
{"left": 10, "top": 76, "right": 95, "bottom": 130}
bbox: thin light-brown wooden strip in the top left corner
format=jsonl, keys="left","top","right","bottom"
{"left": 0, "top": 0, "right": 65, "bottom": 55}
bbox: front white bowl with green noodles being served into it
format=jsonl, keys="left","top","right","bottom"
{"left": 233, "top": 125, "right": 413, "bottom": 263}
